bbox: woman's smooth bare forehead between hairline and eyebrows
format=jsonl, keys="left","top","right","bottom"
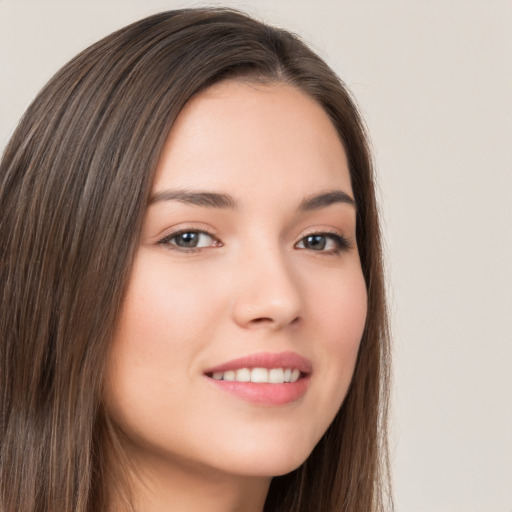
{"left": 154, "top": 80, "right": 352, "bottom": 200}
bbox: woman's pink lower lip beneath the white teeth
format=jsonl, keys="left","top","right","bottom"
{"left": 207, "top": 375, "right": 310, "bottom": 406}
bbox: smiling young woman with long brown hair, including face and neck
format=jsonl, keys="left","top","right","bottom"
{"left": 0, "top": 9, "right": 389, "bottom": 512}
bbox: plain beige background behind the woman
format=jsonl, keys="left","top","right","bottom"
{"left": 0, "top": 0, "right": 512, "bottom": 512}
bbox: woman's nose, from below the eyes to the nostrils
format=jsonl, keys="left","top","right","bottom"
{"left": 233, "top": 251, "right": 303, "bottom": 330}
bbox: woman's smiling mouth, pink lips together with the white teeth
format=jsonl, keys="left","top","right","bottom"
{"left": 204, "top": 352, "right": 312, "bottom": 406}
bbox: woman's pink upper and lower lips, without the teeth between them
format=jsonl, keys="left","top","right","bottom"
{"left": 205, "top": 352, "right": 313, "bottom": 406}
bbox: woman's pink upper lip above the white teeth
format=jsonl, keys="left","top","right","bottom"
{"left": 205, "top": 352, "right": 313, "bottom": 373}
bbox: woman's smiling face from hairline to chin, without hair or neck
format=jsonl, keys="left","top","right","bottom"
{"left": 106, "top": 81, "right": 367, "bottom": 477}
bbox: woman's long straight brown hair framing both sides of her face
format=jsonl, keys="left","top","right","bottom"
{"left": 0, "top": 9, "right": 391, "bottom": 512}
